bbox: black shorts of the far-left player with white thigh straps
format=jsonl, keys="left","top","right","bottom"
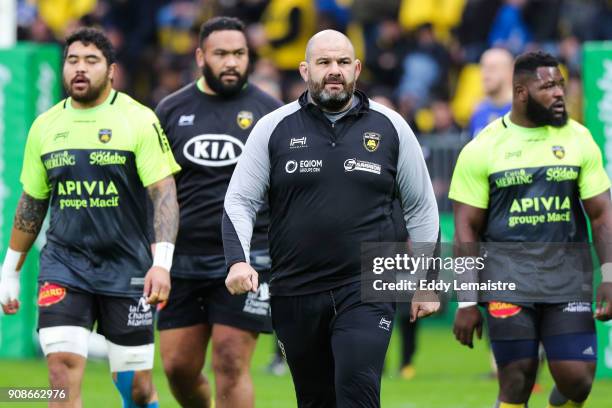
{"left": 38, "top": 282, "right": 155, "bottom": 346}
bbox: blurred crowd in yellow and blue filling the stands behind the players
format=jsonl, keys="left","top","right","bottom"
{"left": 18, "top": 0, "right": 612, "bottom": 137}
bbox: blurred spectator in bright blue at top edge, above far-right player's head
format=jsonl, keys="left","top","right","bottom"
{"left": 489, "top": 0, "right": 533, "bottom": 54}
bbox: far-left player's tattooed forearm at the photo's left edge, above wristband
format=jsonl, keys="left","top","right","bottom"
{"left": 9, "top": 192, "right": 49, "bottom": 252}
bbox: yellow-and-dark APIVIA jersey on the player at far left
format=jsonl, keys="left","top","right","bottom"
{"left": 21, "top": 90, "right": 180, "bottom": 296}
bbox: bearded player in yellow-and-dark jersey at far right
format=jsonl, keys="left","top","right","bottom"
{"left": 449, "top": 52, "right": 612, "bottom": 408}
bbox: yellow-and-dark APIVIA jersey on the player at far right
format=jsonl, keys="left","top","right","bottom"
{"left": 449, "top": 114, "right": 610, "bottom": 302}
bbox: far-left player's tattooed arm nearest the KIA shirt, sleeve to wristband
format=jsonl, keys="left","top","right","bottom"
{"left": 147, "top": 176, "right": 179, "bottom": 243}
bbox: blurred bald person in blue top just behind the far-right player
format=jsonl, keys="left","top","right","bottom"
{"left": 468, "top": 48, "right": 513, "bottom": 138}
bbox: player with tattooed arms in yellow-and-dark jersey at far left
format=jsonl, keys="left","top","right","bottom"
{"left": 0, "top": 28, "right": 180, "bottom": 408}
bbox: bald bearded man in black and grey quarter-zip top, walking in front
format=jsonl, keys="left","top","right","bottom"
{"left": 223, "top": 30, "right": 439, "bottom": 408}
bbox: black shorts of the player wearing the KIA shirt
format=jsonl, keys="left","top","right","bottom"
{"left": 157, "top": 252, "right": 272, "bottom": 333}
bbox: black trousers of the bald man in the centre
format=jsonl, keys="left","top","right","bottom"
{"left": 272, "top": 282, "right": 395, "bottom": 408}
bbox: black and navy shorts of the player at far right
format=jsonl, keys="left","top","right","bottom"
{"left": 487, "top": 302, "right": 597, "bottom": 367}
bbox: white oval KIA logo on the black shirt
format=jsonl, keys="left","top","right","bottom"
{"left": 183, "top": 134, "right": 244, "bottom": 167}
